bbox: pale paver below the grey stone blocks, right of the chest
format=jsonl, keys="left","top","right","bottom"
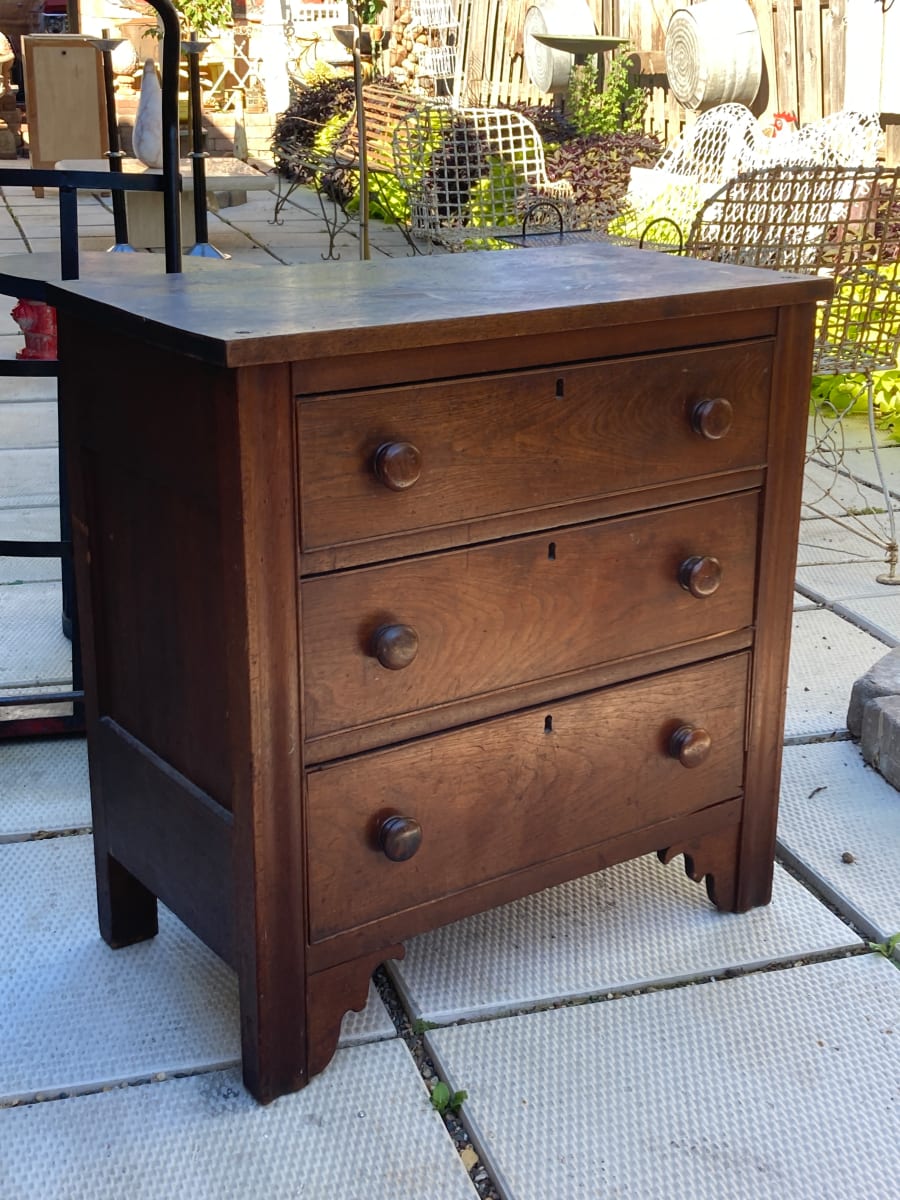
{"left": 779, "top": 742, "right": 900, "bottom": 942}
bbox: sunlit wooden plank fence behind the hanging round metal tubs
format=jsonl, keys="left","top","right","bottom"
{"left": 448, "top": 0, "right": 900, "bottom": 161}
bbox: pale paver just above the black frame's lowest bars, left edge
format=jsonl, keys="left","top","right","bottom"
{"left": 0, "top": 583, "right": 72, "bottom": 689}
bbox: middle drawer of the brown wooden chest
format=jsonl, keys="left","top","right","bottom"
{"left": 301, "top": 492, "right": 758, "bottom": 740}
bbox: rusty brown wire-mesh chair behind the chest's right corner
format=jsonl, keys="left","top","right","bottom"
{"left": 685, "top": 164, "right": 900, "bottom": 583}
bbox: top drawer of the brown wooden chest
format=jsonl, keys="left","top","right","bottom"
{"left": 298, "top": 341, "right": 772, "bottom": 552}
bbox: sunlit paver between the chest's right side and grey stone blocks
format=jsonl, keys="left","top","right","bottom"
{"left": 785, "top": 608, "right": 887, "bottom": 738}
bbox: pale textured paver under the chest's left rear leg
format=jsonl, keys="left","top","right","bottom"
{"left": 0, "top": 834, "right": 395, "bottom": 1104}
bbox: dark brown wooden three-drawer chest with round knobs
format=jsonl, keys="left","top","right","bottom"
{"left": 54, "top": 246, "right": 828, "bottom": 1100}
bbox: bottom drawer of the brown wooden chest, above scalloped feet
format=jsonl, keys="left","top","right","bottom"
{"left": 306, "top": 654, "right": 750, "bottom": 941}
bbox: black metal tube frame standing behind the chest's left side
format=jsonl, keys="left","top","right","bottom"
{"left": 0, "top": 0, "right": 183, "bottom": 739}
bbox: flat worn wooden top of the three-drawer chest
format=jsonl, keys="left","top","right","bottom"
{"left": 48, "top": 245, "right": 830, "bottom": 367}
